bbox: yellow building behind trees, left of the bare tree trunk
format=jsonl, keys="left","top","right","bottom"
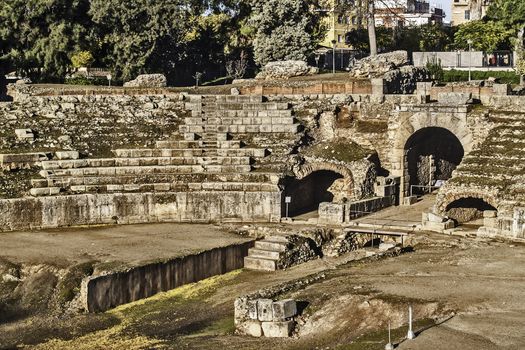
{"left": 321, "top": 0, "right": 368, "bottom": 49}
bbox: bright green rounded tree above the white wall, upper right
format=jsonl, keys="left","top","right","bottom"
{"left": 454, "top": 20, "right": 514, "bottom": 52}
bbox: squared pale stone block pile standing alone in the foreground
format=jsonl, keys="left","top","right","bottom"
{"left": 235, "top": 297, "right": 298, "bottom": 338}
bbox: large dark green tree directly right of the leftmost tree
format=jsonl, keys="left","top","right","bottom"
{"left": 89, "top": 0, "right": 205, "bottom": 80}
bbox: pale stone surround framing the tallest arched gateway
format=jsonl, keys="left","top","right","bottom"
{"left": 390, "top": 107, "right": 474, "bottom": 196}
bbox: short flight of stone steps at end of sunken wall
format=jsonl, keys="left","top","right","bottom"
{"left": 244, "top": 236, "right": 288, "bottom": 271}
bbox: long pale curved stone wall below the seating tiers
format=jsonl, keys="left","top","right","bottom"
{"left": 0, "top": 191, "right": 281, "bottom": 231}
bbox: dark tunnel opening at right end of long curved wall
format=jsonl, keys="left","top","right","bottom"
{"left": 282, "top": 170, "right": 343, "bottom": 217}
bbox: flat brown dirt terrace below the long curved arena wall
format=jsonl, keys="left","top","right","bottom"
{"left": 0, "top": 224, "right": 246, "bottom": 267}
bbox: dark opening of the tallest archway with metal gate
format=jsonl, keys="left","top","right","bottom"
{"left": 403, "top": 127, "right": 465, "bottom": 196}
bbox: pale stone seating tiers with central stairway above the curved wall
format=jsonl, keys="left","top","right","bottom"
{"left": 30, "top": 95, "right": 300, "bottom": 197}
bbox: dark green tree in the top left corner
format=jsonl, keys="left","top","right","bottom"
{"left": 0, "top": 0, "right": 91, "bottom": 81}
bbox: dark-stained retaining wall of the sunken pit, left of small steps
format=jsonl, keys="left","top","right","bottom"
{"left": 82, "top": 241, "right": 253, "bottom": 312}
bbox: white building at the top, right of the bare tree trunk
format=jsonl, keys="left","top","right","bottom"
{"left": 375, "top": 0, "right": 445, "bottom": 28}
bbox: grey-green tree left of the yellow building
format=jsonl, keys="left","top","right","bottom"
{"left": 250, "top": 0, "right": 324, "bottom": 66}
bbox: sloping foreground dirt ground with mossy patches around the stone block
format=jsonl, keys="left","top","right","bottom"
{"left": 0, "top": 224, "right": 525, "bottom": 350}
